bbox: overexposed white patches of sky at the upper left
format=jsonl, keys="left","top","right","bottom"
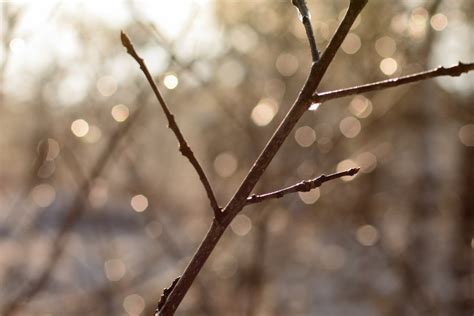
{"left": 0, "top": 0, "right": 220, "bottom": 104}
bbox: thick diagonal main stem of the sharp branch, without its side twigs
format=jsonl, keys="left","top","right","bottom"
{"left": 159, "top": 0, "right": 368, "bottom": 316}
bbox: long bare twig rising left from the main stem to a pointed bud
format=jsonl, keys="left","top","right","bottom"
{"left": 120, "top": 32, "right": 222, "bottom": 221}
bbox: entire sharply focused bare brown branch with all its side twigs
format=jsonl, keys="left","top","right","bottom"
{"left": 121, "top": 0, "right": 473, "bottom": 316}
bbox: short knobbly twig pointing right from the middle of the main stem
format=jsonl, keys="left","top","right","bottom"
{"left": 247, "top": 168, "right": 360, "bottom": 204}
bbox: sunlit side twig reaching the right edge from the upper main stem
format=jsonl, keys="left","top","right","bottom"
{"left": 313, "top": 62, "right": 474, "bottom": 103}
